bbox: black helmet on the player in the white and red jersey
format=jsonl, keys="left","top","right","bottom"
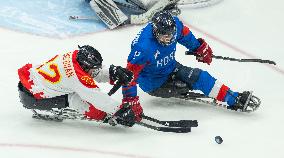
{"left": 77, "top": 45, "right": 103, "bottom": 72}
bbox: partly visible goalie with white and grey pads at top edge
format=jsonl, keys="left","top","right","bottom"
{"left": 86, "top": 0, "right": 180, "bottom": 29}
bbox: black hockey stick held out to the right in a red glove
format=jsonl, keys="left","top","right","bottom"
{"left": 185, "top": 51, "right": 276, "bottom": 65}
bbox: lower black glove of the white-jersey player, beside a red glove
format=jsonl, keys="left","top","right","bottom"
{"left": 114, "top": 105, "right": 135, "bottom": 127}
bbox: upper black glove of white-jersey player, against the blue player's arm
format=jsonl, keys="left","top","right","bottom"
{"left": 109, "top": 65, "right": 133, "bottom": 85}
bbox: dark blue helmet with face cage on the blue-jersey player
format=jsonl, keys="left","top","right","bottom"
{"left": 152, "top": 10, "right": 177, "bottom": 45}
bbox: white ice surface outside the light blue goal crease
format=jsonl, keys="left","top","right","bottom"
{"left": 0, "top": 0, "right": 284, "bottom": 158}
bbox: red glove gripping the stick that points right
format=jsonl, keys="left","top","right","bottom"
{"left": 194, "top": 38, "right": 213, "bottom": 65}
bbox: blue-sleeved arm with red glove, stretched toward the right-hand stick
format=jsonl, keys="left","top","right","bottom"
{"left": 175, "top": 17, "right": 213, "bottom": 65}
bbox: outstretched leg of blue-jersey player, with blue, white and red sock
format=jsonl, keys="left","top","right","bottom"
{"left": 174, "top": 63, "right": 260, "bottom": 110}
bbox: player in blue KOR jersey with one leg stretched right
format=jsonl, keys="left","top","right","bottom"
{"left": 122, "top": 11, "right": 260, "bottom": 112}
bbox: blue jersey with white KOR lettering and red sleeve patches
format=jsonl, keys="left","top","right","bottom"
{"left": 123, "top": 17, "right": 200, "bottom": 96}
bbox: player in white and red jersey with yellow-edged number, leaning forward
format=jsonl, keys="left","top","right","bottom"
{"left": 18, "top": 45, "right": 143, "bottom": 126}
